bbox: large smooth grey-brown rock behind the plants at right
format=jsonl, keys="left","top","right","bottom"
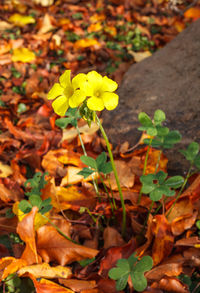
{"left": 102, "top": 19, "right": 200, "bottom": 173}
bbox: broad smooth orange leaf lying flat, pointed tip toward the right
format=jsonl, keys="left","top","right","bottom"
{"left": 37, "top": 225, "right": 98, "bottom": 266}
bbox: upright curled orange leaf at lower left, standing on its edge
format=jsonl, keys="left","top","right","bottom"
{"left": 17, "top": 207, "right": 39, "bottom": 265}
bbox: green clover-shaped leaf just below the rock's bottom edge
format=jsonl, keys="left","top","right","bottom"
{"left": 140, "top": 171, "right": 184, "bottom": 201}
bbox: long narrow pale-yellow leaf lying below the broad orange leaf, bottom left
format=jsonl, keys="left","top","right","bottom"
{"left": 18, "top": 263, "right": 72, "bottom": 279}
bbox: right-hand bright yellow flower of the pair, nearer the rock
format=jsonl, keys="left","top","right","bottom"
{"left": 87, "top": 71, "right": 119, "bottom": 111}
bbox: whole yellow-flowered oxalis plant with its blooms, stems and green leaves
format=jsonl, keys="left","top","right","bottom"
{"left": 48, "top": 70, "right": 126, "bottom": 236}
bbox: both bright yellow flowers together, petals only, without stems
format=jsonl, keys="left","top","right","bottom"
{"left": 47, "top": 70, "right": 119, "bottom": 116}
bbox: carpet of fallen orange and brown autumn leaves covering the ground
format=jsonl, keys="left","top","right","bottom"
{"left": 0, "top": 0, "right": 200, "bottom": 293}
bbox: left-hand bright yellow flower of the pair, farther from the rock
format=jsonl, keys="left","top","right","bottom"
{"left": 47, "top": 70, "right": 87, "bottom": 116}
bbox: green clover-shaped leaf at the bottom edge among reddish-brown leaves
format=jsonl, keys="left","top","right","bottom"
{"left": 108, "top": 254, "right": 153, "bottom": 292}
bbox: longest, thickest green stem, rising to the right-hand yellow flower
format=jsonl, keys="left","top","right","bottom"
{"left": 95, "top": 113, "right": 126, "bottom": 237}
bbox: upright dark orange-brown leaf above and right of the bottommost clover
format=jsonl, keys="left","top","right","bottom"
{"left": 152, "top": 215, "right": 174, "bottom": 266}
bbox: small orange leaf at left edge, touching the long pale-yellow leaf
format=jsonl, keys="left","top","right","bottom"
{"left": 0, "top": 257, "right": 27, "bottom": 280}
